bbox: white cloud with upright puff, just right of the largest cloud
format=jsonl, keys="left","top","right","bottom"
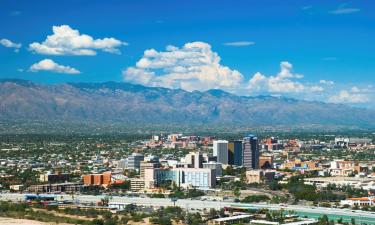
{"left": 248, "top": 62, "right": 305, "bottom": 93}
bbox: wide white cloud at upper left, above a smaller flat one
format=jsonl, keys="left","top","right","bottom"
{"left": 29, "top": 25, "right": 127, "bottom": 55}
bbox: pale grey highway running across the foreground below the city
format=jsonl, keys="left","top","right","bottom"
{"left": 0, "top": 193, "right": 375, "bottom": 224}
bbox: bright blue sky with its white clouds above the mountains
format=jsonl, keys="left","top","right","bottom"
{"left": 0, "top": 0, "right": 375, "bottom": 107}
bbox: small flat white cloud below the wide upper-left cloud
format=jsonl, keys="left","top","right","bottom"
{"left": 30, "top": 59, "right": 81, "bottom": 74}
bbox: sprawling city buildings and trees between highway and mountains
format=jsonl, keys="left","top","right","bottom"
{"left": 0, "top": 134, "right": 375, "bottom": 198}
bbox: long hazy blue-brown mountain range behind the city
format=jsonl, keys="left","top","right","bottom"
{"left": 0, "top": 80, "right": 375, "bottom": 128}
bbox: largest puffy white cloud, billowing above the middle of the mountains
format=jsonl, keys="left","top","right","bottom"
{"left": 123, "top": 42, "right": 243, "bottom": 91}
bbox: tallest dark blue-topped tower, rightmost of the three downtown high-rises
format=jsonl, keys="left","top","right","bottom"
{"left": 242, "top": 134, "right": 259, "bottom": 170}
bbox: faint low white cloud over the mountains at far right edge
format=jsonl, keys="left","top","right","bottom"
{"left": 328, "top": 86, "right": 371, "bottom": 104}
